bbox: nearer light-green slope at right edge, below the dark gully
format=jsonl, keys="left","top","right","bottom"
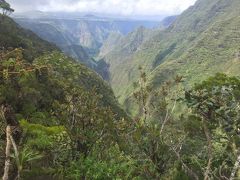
{"left": 151, "top": 16, "right": 240, "bottom": 88}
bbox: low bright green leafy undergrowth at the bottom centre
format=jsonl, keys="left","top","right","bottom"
{"left": 61, "top": 145, "right": 140, "bottom": 180}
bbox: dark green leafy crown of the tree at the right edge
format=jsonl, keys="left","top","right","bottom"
{"left": 186, "top": 74, "right": 240, "bottom": 134}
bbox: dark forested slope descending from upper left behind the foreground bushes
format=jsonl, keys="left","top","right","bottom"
{"left": 0, "top": 15, "right": 127, "bottom": 119}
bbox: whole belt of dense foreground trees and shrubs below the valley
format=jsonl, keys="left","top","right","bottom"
{"left": 0, "top": 49, "right": 240, "bottom": 179}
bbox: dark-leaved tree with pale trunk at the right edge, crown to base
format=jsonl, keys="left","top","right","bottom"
{"left": 185, "top": 74, "right": 240, "bottom": 179}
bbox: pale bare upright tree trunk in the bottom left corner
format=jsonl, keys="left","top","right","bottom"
{"left": 2, "top": 125, "right": 11, "bottom": 180}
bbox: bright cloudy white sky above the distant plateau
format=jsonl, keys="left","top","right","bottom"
{"left": 7, "top": 0, "right": 196, "bottom": 16}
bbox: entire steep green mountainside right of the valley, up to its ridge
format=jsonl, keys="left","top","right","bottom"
{"left": 100, "top": 0, "right": 240, "bottom": 111}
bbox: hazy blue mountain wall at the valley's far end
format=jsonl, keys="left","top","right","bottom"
{"left": 14, "top": 16, "right": 161, "bottom": 54}
